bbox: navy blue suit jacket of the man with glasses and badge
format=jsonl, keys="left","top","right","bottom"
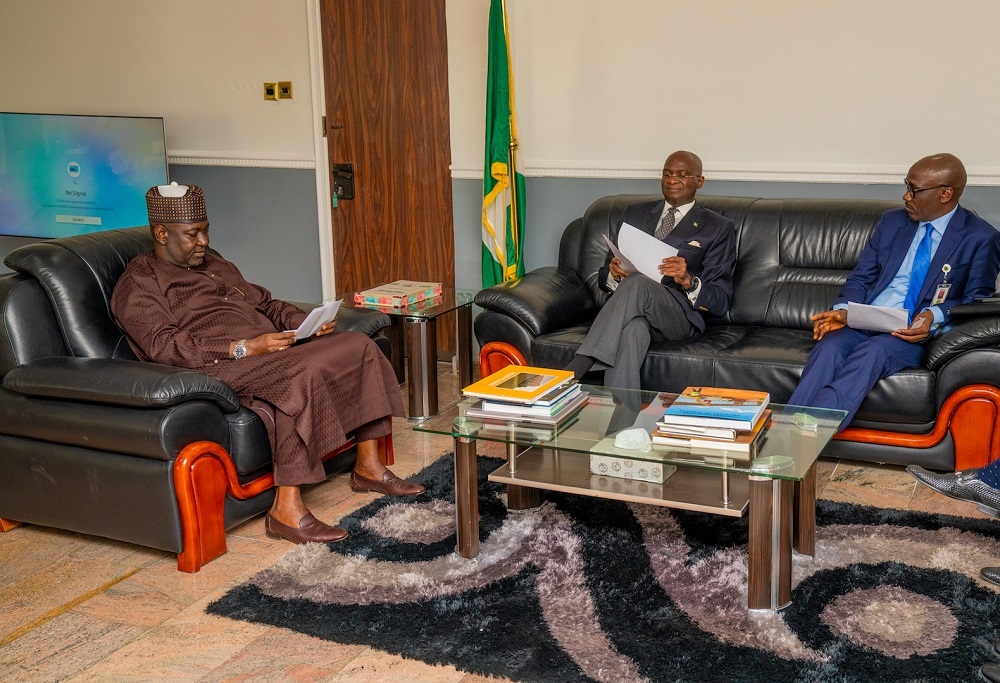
{"left": 834, "top": 206, "right": 1000, "bottom": 322}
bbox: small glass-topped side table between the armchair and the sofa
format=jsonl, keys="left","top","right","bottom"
{"left": 352, "top": 287, "right": 476, "bottom": 419}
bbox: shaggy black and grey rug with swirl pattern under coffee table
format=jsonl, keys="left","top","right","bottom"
{"left": 208, "top": 457, "right": 1000, "bottom": 682}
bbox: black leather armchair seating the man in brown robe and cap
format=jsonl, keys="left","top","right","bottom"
{"left": 0, "top": 228, "right": 392, "bottom": 572}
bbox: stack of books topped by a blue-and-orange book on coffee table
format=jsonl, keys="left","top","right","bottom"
{"left": 652, "top": 387, "right": 771, "bottom": 458}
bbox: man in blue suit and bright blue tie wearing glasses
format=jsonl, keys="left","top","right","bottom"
{"left": 788, "top": 154, "right": 1000, "bottom": 426}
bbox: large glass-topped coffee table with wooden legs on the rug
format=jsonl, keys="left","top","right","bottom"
{"left": 414, "top": 385, "right": 847, "bottom": 610}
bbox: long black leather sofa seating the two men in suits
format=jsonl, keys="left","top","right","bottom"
{"left": 475, "top": 195, "right": 1000, "bottom": 470}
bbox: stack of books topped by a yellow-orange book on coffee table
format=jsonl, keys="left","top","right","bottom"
{"left": 462, "top": 365, "right": 588, "bottom": 440}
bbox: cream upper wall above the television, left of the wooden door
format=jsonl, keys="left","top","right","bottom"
{"left": 0, "top": 0, "right": 315, "bottom": 168}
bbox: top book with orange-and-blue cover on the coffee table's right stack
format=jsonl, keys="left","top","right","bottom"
{"left": 663, "top": 387, "right": 771, "bottom": 430}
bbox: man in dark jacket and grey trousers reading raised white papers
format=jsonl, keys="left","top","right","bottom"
{"left": 567, "top": 152, "right": 736, "bottom": 389}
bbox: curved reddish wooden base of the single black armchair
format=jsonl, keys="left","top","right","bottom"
{"left": 174, "top": 434, "right": 394, "bottom": 573}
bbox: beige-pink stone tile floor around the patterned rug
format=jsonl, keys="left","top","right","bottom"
{"left": 0, "top": 364, "right": 996, "bottom": 683}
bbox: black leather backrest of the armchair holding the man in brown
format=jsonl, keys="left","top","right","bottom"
{"left": 4, "top": 228, "right": 153, "bottom": 360}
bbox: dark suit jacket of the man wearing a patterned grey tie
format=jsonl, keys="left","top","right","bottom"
{"left": 597, "top": 199, "right": 736, "bottom": 332}
